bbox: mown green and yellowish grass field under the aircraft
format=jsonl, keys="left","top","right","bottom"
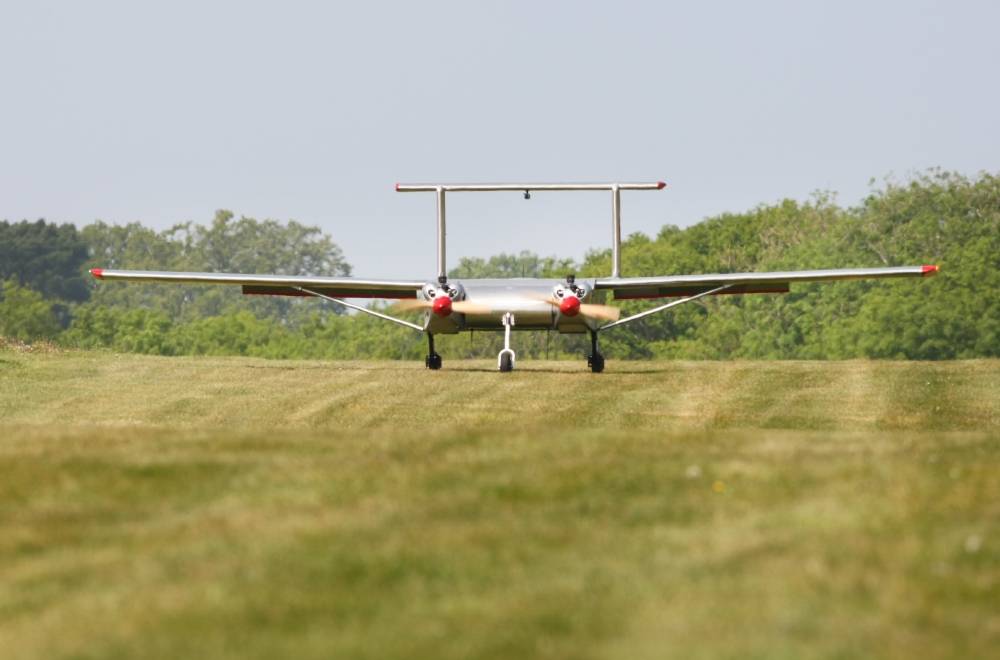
{"left": 0, "top": 351, "right": 1000, "bottom": 658}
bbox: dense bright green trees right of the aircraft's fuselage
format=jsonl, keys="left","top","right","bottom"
{"left": 581, "top": 171, "right": 1000, "bottom": 359}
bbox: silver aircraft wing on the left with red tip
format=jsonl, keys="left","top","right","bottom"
{"left": 90, "top": 268, "right": 424, "bottom": 298}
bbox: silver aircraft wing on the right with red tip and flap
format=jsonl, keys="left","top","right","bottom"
{"left": 594, "top": 266, "right": 938, "bottom": 300}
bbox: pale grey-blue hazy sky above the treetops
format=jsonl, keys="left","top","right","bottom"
{"left": 0, "top": 0, "right": 1000, "bottom": 279}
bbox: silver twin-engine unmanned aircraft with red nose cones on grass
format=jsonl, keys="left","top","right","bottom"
{"left": 90, "top": 181, "right": 938, "bottom": 373}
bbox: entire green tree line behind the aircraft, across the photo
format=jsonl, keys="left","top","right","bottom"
{"left": 0, "top": 171, "right": 1000, "bottom": 360}
